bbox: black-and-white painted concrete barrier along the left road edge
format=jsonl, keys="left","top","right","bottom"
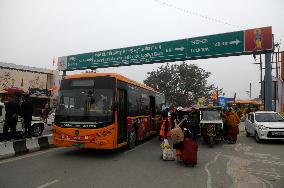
{"left": 0, "top": 134, "right": 53, "bottom": 159}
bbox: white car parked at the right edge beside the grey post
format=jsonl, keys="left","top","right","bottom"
{"left": 245, "top": 111, "right": 284, "bottom": 143}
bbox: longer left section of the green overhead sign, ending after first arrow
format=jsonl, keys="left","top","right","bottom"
{"left": 59, "top": 39, "right": 187, "bottom": 70}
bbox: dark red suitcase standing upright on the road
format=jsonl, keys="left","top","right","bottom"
{"left": 180, "top": 138, "right": 198, "bottom": 166}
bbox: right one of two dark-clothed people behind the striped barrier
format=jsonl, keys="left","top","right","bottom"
{"left": 21, "top": 95, "right": 33, "bottom": 138}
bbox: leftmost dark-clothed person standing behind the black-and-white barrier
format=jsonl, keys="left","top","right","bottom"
{"left": 3, "top": 95, "right": 20, "bottom": 140}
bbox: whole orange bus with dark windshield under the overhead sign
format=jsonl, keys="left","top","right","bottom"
{"left": 53, "top": 73, "right": 165, "bottom": 149}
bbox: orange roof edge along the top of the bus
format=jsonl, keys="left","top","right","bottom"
{"left": 64, "top": 72, "right": 161, "bottom": 94}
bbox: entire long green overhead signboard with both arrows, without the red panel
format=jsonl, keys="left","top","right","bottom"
{"left": 58, "top": 31, "right": 244, "bottom": 70}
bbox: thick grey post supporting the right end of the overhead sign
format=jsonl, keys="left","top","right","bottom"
{"left": 264, "top": 52, "right": 272, "bottom": 111}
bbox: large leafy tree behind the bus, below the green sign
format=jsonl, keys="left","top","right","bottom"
{"left": 144, "top": 62, "right": 220, "bottom": 106}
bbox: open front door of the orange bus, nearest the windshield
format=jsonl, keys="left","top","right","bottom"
{"left": 117, "top": 89, "right": 127, "bottom": 144}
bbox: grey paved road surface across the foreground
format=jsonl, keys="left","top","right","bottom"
{"left": 0, "top": 123, "right": 284, "bottom": 188}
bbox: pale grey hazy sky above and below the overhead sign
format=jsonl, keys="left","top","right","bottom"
{"left": 0, "top": 0, "right": 284, "bottom": 98}
